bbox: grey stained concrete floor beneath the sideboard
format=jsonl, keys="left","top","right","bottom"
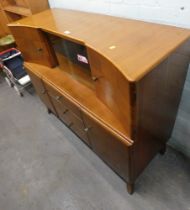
{"left": 0, "top": 77, "right": 190, "bottom": 210}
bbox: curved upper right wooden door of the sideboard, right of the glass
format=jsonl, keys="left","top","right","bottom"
{"left": 88, "top": 49, "right": 132, "bottom": 138}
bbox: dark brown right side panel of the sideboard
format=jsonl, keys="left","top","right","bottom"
{"left": 134, "top": 40, "right": 190, "bottom": 179}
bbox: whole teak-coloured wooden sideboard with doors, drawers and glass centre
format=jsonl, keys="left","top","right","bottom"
{"left": 9, "top": 9, "right": 190, "bottom": 193}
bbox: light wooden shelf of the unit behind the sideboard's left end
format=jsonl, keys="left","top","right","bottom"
{"left": 3, "top": 5, "right": 32, "bottom": 17}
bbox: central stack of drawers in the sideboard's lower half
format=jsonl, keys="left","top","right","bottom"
{"left": 45, "top": 82, "right": 90, "bottom": 146}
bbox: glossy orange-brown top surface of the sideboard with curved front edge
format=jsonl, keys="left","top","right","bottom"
{"left": 9, "top": 9, "right": 190, "bottom": 82}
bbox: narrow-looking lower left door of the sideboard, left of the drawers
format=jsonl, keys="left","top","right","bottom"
{"left": 26, "top": 68, "right": 57, "bottom": 115}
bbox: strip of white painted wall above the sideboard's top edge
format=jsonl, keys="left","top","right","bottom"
{"left": 49, "top": 0, "right": 190, "bottom": 28}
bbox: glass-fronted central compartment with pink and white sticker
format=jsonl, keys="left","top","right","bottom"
{"left": 46, "top": 34, "right": 94, "bottom": 89}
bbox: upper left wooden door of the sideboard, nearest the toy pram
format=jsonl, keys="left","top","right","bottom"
{"left": 10, "top": 25, "right": 56, "bottom": 67}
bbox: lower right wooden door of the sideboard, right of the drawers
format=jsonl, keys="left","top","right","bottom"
{"left": 83, "top": 113, "right": 129, "bottom": 181}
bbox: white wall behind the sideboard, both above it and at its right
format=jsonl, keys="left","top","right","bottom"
{"left": 49, "top": 0, "right": 190, "bottom": 157}
